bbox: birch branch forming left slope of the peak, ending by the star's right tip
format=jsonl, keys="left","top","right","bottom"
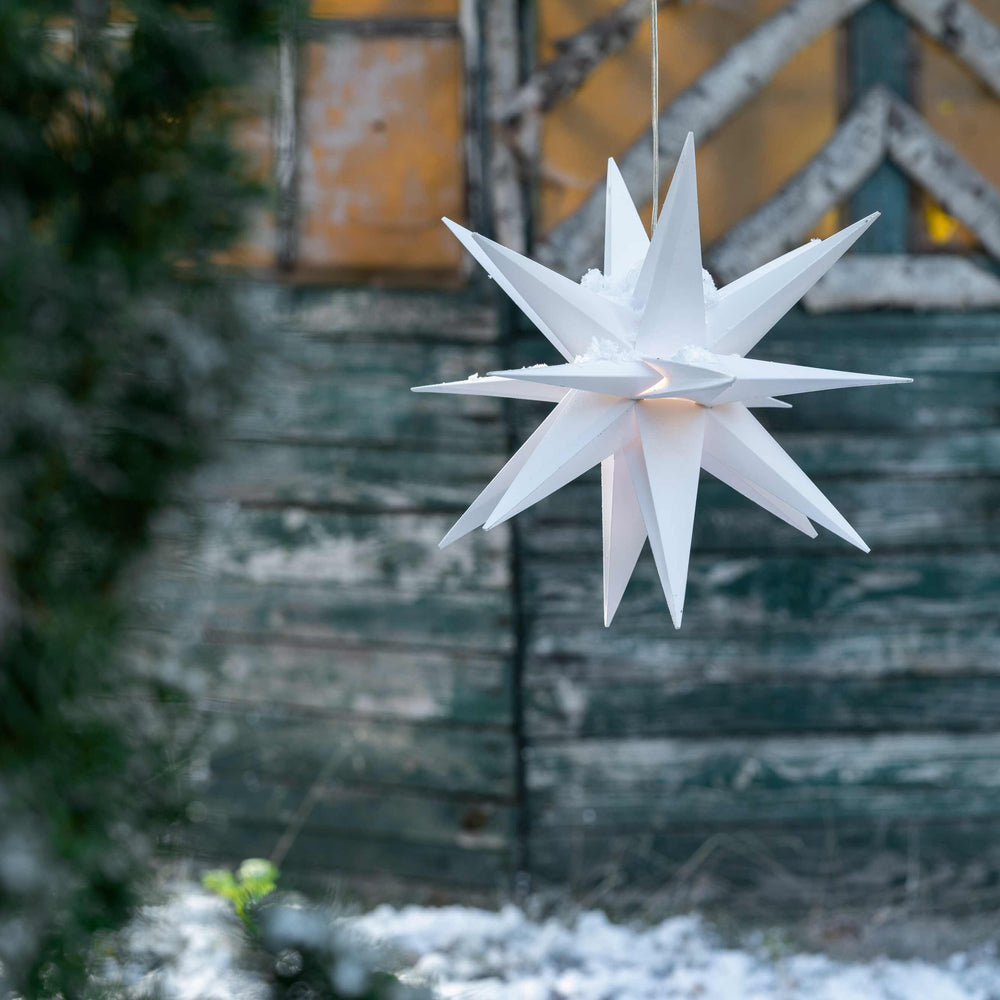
{"left": 706, "top": 88, "right": 892, "bottom": 282}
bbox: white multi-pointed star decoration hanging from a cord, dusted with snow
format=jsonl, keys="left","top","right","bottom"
{"left": 414, "top": 135, "right": 910, "bottom": 628}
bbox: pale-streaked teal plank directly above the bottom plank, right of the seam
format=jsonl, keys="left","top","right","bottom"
{"left": 528, "top": 733, "right": 1000, "bottom": 831}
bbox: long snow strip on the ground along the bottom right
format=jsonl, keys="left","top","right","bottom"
{"left": 353, "top": 906, "right": 1000, "bottom": 1000}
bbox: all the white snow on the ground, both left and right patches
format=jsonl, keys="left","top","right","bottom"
{"left": 95, "top": 883, "right": 1000, "bottom": 1000}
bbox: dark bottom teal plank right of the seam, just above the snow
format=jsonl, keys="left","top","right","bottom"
{"left": 532, "top": 813, "right": 1000, "bottom": 919}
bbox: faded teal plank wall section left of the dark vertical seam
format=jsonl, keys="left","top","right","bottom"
{"left": 180, "top": 290, "right": 516, "bottom": 894}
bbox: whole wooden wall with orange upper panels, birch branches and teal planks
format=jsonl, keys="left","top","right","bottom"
{"left": 143, "top": 0, "right": 1000, "bottom": 912}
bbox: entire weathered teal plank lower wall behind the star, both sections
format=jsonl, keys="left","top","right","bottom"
{"left": 176, "top": 291, "right": 1000, "bottom": 912}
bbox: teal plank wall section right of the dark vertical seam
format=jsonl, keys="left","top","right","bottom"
{"left": 519, "top": 302, "right": 1000, "bottom": 914}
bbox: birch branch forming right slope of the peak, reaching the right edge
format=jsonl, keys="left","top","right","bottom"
{"left": 889, "top": 98, "right": 1000, "bottom": 257}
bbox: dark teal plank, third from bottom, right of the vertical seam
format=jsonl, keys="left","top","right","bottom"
{"left": 525, "top": 667, "right": 1000, "bottom": 742}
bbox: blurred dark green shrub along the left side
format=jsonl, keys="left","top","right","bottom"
{"left": 0, "top": 0, "right": 291, "bottom": 998}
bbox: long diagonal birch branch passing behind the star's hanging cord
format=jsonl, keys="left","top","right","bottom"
{"left": 539, "top": 0, "right": 867, "bottom": 274}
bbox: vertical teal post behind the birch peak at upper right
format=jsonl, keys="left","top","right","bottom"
{"left": 846, "top": 0, "right": 913, "bottom": 253}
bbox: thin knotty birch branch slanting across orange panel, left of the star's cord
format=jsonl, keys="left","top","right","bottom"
{"left": 498, "top": 0, "right": 690, "bottom": 122}
